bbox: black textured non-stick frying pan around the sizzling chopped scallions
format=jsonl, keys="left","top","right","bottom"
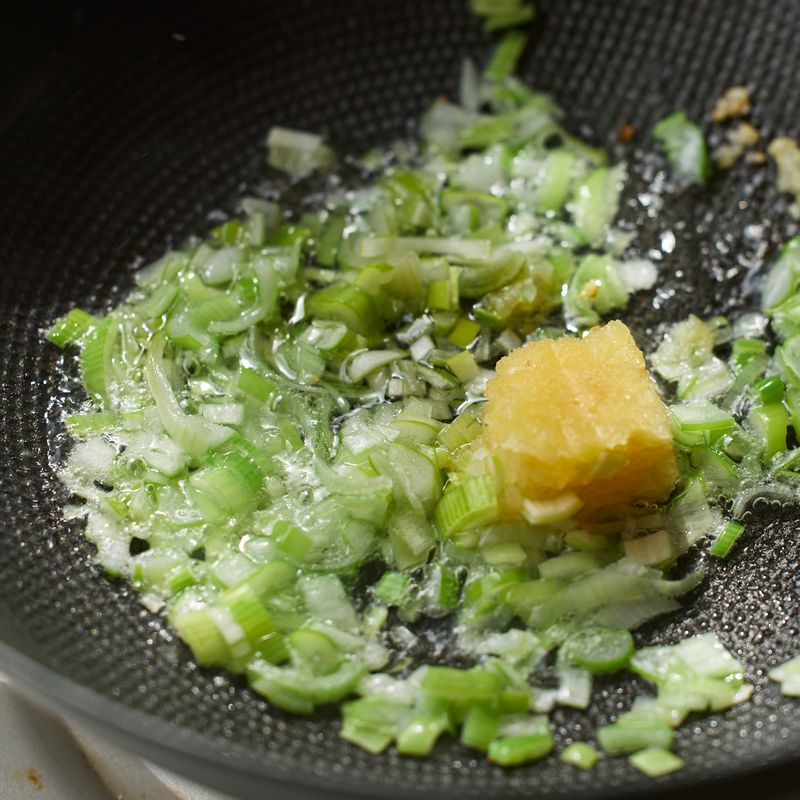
{"left": 0, "top": 0, "right": 800, "bottom": 800}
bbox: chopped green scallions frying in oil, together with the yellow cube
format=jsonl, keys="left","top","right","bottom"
{"left": 48, "top": 9, "right": 800, "bottom": 775}
